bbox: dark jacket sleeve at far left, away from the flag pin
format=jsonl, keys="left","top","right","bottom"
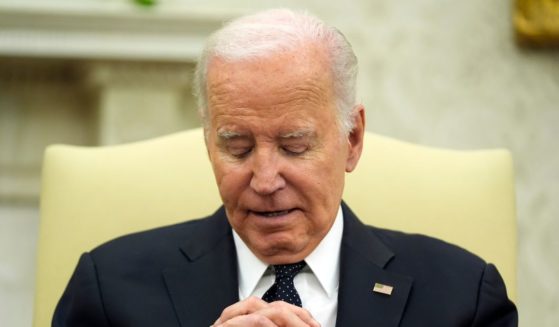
{"left": 52, "top": 253, "right": 110, "bottom": 327}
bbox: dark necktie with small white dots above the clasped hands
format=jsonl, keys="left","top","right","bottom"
{"left": 262, "top": 261, "right": 306, "bottom": 307}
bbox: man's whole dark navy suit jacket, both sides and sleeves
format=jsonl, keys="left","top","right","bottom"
{"left": 53, "top": 204, "right": 517, "bottom": 327}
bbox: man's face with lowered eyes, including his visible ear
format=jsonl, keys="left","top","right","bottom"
{"left": 207, "top": 47, "right": 363, "bottom": 264}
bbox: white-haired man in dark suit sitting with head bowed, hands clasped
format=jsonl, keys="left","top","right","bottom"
{"left": 53, "top": 10, "right": 517, "bottom": 327}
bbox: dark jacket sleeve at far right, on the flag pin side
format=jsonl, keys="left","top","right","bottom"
{"left": 472, "top": 264, "right": 518, "bottom": 327}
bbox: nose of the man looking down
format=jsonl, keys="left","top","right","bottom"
{"left": 250, "top": 151, "right": 286, "bottom": 195}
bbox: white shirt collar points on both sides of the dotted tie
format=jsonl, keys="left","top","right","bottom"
{"left": 233, "top": 206, "right": 343, "bottom": 297}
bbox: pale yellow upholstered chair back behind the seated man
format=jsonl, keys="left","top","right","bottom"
{"left": 34, "top": 129, "right": 516, "bottom": 327}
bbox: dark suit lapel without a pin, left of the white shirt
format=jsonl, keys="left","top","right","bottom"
{"left": 163, "top": 209, "right": 239, "bottom": 327}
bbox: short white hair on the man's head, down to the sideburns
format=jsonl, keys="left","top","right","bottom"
{"left": 194, "top": 9, "right": 357, "bottom": 134}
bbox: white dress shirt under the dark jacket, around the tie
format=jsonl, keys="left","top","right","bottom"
{"left": 233, "top": 207, "right": 343, "bottom": 327}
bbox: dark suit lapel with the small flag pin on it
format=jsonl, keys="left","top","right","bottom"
{"left": 336, "top": 203, "right": 412, "bottom": 327}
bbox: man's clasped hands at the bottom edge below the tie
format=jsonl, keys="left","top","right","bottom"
{"left": 213, "top": 296, "right": 320, "bottom": 327}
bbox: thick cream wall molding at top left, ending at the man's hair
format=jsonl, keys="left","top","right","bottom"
{"left": 0, "top": 7, "right": 236, "bottom": 62}
